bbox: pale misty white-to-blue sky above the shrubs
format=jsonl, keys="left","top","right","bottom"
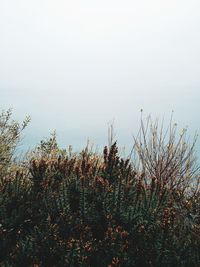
{"left": 0, "top": 0, "right": 200, "bottom": 156}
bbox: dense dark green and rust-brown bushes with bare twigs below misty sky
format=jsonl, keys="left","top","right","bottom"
{"left": 0, "top": 110, "right": 200, "bottom": 267}
